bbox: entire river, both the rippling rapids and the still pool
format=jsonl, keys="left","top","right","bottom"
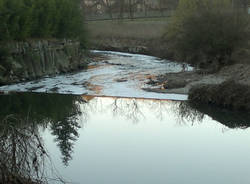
{"left": 0, "top": 52, "right": 250, "bottom": 184}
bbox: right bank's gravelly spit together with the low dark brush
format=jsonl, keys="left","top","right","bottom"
{"left": 144, "top": 64, "right": 250, "bottom": 112}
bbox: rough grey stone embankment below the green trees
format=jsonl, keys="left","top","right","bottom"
{"left": 0, "top": 40, "right": 89, "bottom": 85}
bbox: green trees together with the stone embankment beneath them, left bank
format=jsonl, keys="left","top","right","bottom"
{"left": 0, "top": 0, "right": 88, "bottom": 85}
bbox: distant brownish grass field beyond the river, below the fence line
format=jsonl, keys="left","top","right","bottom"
{"left": 87, "top": 18, "right": 169, "bottom": 40}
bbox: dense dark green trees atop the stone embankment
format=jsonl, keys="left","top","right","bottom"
{"left": 0, "top": 0, "right": 85, "bottom": 41}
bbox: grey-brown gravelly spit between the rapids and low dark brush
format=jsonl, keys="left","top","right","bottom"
{"left": 144, "top": 64, "right": 250, "bottom": 94}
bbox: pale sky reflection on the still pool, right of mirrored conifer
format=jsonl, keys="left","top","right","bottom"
{"left": 51, "top": 96, "right": 250, "bottom": 184}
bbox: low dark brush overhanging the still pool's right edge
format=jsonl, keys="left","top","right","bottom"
{"left": 188, "top": 80, "right": 250, "bottom": 112}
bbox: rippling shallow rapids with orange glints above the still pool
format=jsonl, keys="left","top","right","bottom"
{"left": 0, "top": 51, "right": 192, "bottom": 100}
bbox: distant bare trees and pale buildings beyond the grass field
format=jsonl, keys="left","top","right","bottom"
{"left": 82, "top": 0, "right": 179, "bottom": 20}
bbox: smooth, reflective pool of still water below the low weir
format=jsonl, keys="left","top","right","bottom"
{"left": 0, "top": 93, "right": 250, "bottom": 184}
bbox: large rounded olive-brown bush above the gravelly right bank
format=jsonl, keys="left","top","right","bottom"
{"left": 165, "top": 0, "right": 249, "bottom": 66}
